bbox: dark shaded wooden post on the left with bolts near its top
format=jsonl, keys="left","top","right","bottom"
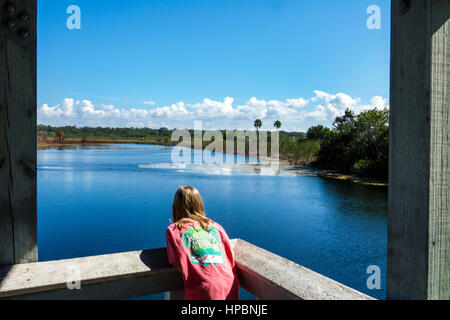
{"left": 0, "top": 0, "right": 37, "bottom": 265}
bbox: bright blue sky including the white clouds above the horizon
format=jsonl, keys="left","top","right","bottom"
{"left": 38, "top": 0, "right": 390, "bottom": 130}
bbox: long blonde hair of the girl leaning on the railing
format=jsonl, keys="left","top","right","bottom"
{"left": 172, "top": 187, "right": 213, "bottom": 231}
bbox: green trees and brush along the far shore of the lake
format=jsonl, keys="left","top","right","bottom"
{"left": 37, "top": 109, "right": 389, "bottom": 185}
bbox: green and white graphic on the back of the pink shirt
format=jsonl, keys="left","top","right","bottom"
{"left": 181, "top": 226, "right": 224, "bottom": 267}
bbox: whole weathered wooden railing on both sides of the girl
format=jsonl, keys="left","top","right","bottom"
{"left": 0, "top": 239, "right": 372, "bottom": 300}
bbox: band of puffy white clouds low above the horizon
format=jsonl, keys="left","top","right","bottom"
{"left": 38, "top": 90, "right": 387, "bottom": 131}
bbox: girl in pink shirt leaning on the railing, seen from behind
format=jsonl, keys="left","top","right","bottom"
{"left": 166, "top": 187, "right": 239, "bottom": 300}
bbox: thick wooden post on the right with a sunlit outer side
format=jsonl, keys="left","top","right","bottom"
{"left": 387, "top": 0, "right": 450, "bottom": 299}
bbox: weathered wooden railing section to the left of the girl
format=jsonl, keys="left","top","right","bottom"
{"left": 0, "top": 249, "right": 184, "bottom": 300}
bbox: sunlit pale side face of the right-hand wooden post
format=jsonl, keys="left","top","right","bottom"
{"left": 428, "top": 0, "right": 450, "bottom": 300}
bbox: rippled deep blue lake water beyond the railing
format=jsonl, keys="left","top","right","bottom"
{"left": 38, "top": 145, "right": 387, "bottom": 299}
